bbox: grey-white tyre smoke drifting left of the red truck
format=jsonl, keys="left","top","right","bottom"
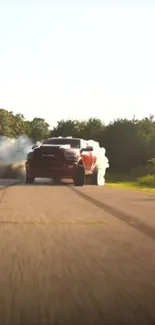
{"left": 0, "top": 136, "right": 33, "bottom": 178}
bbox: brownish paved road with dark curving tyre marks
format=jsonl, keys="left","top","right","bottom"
{"left": 0, "top": 180, "right": 155, "bottom": 325}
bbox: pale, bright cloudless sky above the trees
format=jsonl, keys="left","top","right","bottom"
{"left": 0, "top": 0, "right": 155, "bottom": 126}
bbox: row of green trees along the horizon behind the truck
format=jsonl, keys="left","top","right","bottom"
{"left": 0, "top": 109, "right": 155, "bottom": 173}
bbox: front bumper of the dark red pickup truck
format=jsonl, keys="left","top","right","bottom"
{"left": 25, "top": 162, "right": 77, "bottom": 178}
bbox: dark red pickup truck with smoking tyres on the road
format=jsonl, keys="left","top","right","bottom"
{"left": 25, "top": 137, "right": 108, "bottom": 186}
